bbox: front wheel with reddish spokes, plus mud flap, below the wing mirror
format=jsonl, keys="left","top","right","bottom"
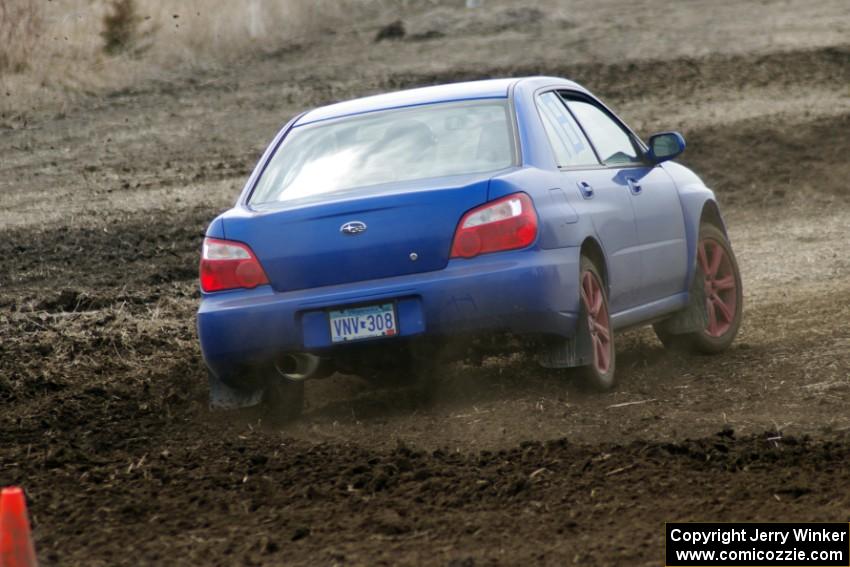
{"left": 653, "top": 224, "right": 744, "bottom": 354}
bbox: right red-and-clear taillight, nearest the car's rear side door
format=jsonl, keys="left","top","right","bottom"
{"left": 451, "top": 193, "right": 537, "bottom": 258}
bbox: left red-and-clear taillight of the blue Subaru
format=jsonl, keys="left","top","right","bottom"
{"left": 201, "top": 238, "right": 269, "bottom": 292}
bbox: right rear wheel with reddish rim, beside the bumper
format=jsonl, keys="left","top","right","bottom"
{"left": 578, "top": 256, "right": 616, "bottom": 390}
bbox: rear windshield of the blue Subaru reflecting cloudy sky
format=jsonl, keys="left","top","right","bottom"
{"left": 250, "top": 99, "right": 516, "bottom": 204}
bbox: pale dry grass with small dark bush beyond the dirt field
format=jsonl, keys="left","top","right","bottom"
{"left": 0, "top": 0, "right": 390, "bottom": 112}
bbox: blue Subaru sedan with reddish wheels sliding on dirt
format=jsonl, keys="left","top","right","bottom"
{"left": 198, "top": 77, "right": 743, "bottom": 418}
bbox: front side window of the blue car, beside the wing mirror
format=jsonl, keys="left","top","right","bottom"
{"left": 566, "top": 99, "right": 643, "bottom": 165}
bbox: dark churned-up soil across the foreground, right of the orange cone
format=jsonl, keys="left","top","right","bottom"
{"left": 9, "top": 430, "right": 850, "bottom": 565}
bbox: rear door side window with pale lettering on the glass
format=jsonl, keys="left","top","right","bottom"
{"left": 537, "top": 92, "right": 599, "bottom": 167}
